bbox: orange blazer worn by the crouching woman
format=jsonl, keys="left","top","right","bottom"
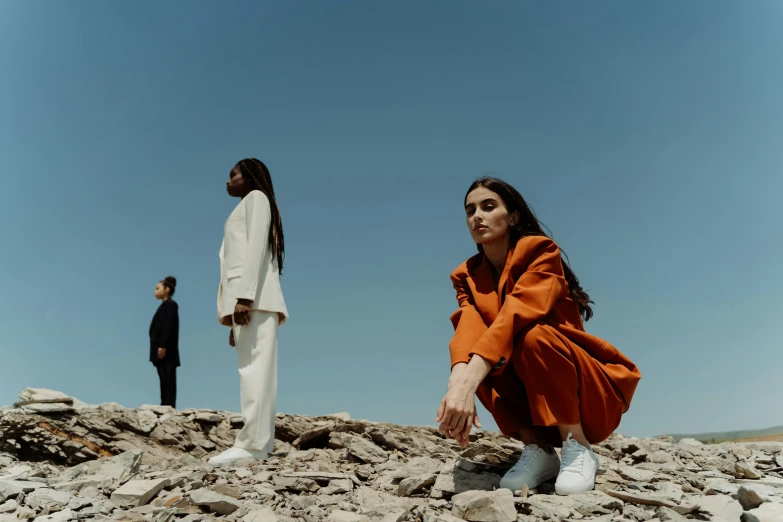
{"left": 449, "top": 236, "right": 641, "bottom": 410}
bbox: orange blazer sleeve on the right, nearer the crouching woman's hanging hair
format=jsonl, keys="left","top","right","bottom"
{"left": 470, "top": 237, "right": 568, "bottom": 374}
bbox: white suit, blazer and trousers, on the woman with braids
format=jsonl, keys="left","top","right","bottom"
{"left": 217, "top": 190, "right": 288, "bottom": 453}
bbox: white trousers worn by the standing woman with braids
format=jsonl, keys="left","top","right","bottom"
{"left": 233, "top": 311, "right": 280, "bottom": 453}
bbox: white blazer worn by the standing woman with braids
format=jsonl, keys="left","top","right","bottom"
{"left": 217, "top": 190, "right": 288, "bottom": 326}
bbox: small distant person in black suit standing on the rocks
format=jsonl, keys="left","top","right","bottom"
{"left": 150, "top": 276, "right": 179, "bottom": 408}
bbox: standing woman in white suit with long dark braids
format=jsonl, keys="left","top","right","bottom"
{"left": 209, "top": 159, "right": 288, "bottom": 466}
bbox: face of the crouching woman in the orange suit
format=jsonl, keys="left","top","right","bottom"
{"left": 465, "top": 187, "right": 518, "bottom": 245}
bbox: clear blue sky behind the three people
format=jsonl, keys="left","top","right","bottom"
{"left": 0, "top": 0, "right": 783, "bottom": 436}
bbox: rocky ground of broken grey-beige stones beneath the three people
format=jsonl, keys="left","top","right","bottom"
{"left": 0, "top": 389, "right": 783, "bottom": 522}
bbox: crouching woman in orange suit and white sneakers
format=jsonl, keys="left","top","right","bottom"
{"left": 437, "top": 178, "right": 641, "bottom": 495}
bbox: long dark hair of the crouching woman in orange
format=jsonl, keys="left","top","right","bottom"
{"left": 465, "top": 177, "right": 593, "bottom": 321}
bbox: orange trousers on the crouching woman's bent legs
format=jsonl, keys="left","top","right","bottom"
{"left": 477, "top": 323, "right": 626, "bottom": 446}
